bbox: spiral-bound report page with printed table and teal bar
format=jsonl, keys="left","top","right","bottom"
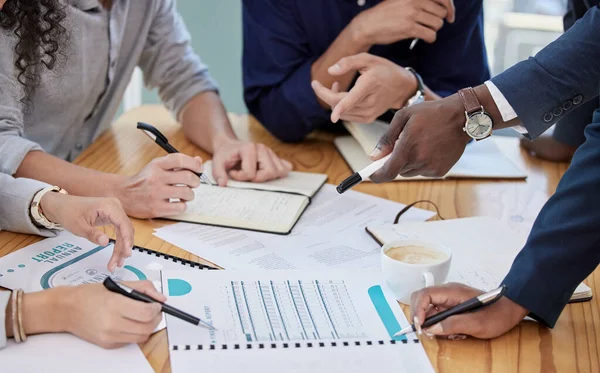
{"left": 162, "top": 269, "right": 433, "bottom": 373}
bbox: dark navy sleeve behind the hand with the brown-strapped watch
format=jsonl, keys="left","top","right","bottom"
{"left": 412, "top": 0, "right": 490, "bottom": 97}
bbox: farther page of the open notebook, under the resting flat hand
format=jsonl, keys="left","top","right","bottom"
{"left": 204, "top": 161, "right": 327, "bottom": 197}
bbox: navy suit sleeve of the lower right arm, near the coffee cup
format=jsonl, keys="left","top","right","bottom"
{"left": 504, "top": 111, "right": 600, "bottom": 327}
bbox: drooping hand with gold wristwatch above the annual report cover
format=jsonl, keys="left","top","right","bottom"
{"left": 40, "top": 192, "right": 134, "bottom": 272}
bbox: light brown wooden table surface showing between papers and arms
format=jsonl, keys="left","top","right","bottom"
{"left": 0, "top": 106, "right": 600, "bottom": 373}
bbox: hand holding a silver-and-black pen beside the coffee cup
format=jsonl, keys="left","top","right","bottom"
{"left": 411, "top": 283, "right": 529, "bottom": 339}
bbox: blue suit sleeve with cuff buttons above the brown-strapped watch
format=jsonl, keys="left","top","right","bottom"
{"left": 492, "top": 7, "right": 600, "bottom": 138}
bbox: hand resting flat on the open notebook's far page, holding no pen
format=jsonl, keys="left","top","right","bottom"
{"left": 212, "top": 140, "right": 292, "bottom": 186}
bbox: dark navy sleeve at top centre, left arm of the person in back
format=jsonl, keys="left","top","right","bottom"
{"left": 243, "top": 0, "right": 330, "bottom": 142}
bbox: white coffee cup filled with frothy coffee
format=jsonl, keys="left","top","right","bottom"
{"left": 381, "top": 240, "right": 452, "bottom": 305}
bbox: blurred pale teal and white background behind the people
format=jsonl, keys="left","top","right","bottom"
{"left": 124, "top": 0, "right": 567, "bottom": 113}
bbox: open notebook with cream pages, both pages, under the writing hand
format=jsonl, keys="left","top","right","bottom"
{"left": 169, "top": 162, "right": 327, "bottom": 234}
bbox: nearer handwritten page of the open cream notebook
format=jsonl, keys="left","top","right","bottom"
{"left": 169, "top": 184, "right": 309, "bottom": 233}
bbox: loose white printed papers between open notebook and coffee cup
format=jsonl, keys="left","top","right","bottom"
{"left": 154, "top": 184, "right": 435, "bottom": 270}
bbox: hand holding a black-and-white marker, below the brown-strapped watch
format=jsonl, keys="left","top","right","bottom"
{"left": 371, "top": 94, "right": 471, "bottom": 183}
